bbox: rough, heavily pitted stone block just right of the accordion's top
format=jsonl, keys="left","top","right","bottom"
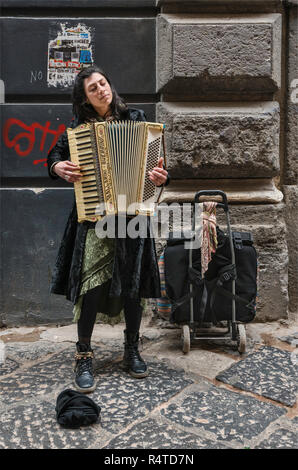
{"left": 157, "top": 102, "right": 280, "bottom": 179}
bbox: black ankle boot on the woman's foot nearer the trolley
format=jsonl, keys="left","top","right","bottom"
{"left": 123, "top": 330, "right": 149, "bottom": 379}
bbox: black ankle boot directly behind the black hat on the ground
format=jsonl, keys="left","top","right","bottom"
{"left": 75, "top": 342, "right": 95, "bottom": 393}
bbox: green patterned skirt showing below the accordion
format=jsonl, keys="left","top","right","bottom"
{"left": 73, "top": 228, "right": 124, "bottom": 325}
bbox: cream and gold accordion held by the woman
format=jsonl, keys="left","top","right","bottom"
{"left": 67, "top": 121, "right": 164, "bottom": 222}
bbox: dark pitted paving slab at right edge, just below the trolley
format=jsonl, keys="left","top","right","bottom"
{"left": 216, "top": 347, "right": 297, "bottom": 406}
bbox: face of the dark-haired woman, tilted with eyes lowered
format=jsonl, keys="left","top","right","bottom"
{"left": 84, "top": 72, "right": 113, "bottom": 117}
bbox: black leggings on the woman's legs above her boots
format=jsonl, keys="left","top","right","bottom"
{"left": 78, "top": 287, "right": 143, "bottom": 344}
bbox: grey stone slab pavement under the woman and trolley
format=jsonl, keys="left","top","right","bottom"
{"left": 0, "top": 318, "right": 298, "bottom": 449}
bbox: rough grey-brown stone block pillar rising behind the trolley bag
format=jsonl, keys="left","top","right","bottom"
{"left": 157, "top": 0, "right": 288, "bottom": 321}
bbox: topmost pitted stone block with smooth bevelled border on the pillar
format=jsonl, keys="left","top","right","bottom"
{"left": 157, "top": 13, "right": 281, "bottom": 97}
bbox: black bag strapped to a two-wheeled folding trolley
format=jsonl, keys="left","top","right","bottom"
{"left": 164, "top": 190, "right": 257, "bottom": 353}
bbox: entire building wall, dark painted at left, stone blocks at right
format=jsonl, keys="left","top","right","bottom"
{"left": 0, "top": 0, "right": 298, "bottom": 325}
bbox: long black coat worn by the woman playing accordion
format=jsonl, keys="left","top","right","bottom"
{"left": 48, "top": 108, "right": 169, "bottom": 303}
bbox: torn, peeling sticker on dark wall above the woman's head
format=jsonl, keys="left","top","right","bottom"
{"left": 47, "top": 23, "right": 94, "bottom": 87}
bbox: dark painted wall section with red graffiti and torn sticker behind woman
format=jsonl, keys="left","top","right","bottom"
{"left": 0, "top": 6, "right": 156, "bottom": 326}
